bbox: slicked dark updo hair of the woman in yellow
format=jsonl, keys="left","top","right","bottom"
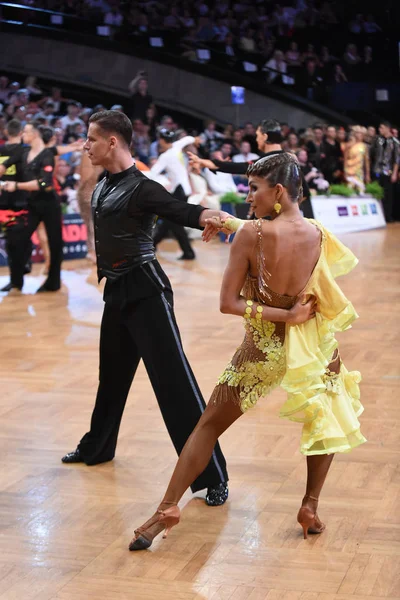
{"left": 247, "top": 152, "right": 303, "bottom": 202}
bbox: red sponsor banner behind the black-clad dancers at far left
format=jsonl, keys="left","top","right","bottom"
{"left": 0, "top": 213, "right": 87, "bottom": 266}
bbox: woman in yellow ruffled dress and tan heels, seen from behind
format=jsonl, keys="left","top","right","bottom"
{"left": 130, "top": 153, "right": 366, "bottom": 550}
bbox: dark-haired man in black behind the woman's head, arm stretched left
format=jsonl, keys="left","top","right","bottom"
{"left": 189, "top": 119, "right": 314, "bottom": 218}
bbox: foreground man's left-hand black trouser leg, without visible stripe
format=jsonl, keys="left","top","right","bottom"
{"left": 78, "top": 304, "right": 140, "bottom": 465}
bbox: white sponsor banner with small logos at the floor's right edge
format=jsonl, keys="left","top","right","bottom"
{"left": 311, "top": 196, "right": 386, "bottom": 233}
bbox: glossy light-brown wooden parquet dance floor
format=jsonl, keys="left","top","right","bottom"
{"left": 0, "top": 224, "right": 400, "bottom": 600}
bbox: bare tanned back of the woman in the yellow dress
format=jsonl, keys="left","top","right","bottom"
{"left": 250, "top": 218, "right": 322, "bottom": 296}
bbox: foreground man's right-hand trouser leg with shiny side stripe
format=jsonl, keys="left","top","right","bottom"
{"left": 127, "top": 263, "right": 228, "bottom": 492}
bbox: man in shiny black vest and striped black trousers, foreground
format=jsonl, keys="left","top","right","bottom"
{"left": 62, "top": 110, "right": 228, "bottom": 506}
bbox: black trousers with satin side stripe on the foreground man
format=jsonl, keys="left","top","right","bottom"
{"left": 78, "top": 261, "right": 228, "bottom": 491}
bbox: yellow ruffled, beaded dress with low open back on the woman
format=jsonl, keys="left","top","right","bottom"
{"left": 211, "top": 219, "right": 366, "bottom": 456}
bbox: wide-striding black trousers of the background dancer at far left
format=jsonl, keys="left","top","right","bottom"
{"left": 7, "top": 192, "right": 63, "bottom": 290}
